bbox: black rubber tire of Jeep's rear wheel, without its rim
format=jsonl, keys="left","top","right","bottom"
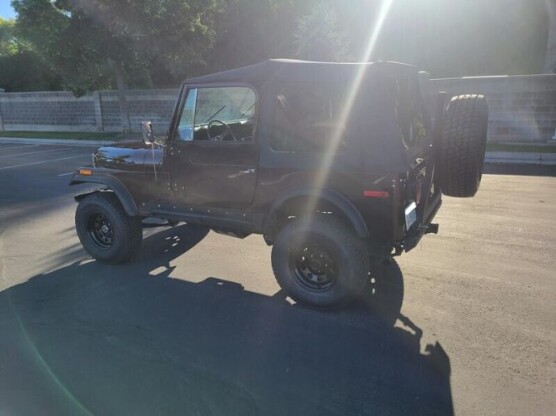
{"left": 272, "top": 215, "right": 370, "bottom": 308}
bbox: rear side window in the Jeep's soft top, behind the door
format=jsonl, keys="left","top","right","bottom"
{"left": 270, "top": 84, "right": 346, "bottom": 153}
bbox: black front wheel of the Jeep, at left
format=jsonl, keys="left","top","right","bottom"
{"left": 75, "top": 192, "right": 143, "bottom": 264}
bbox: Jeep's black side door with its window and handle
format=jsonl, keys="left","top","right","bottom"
{"left": 165, "top": 85, "right": 259, "bottom": 209}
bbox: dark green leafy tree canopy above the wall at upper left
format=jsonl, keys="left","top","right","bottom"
{"left": 12, "top": 0, "right": 217, "bottom": 94}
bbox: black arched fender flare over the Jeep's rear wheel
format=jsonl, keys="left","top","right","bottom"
{"left": 264, "top": 189, "right": 370, "bottom": 238}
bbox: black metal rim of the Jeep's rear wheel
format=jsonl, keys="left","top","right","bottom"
{"left": 289, "top": 245, "right": 338, "bottom": 292}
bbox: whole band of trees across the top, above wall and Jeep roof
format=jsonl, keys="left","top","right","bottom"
{"left": 4, "top": 0, "right": 548, "bottom": 93}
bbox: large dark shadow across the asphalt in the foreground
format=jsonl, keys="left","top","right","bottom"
{"left": 0, "top": 226, "right": 453, "bottom": 416}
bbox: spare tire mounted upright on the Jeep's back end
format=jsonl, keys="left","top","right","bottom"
{"left": 437, "top": 94, "right": 488, "bottom": 198}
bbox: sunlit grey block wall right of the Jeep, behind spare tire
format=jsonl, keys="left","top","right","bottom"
{"left": 432, "top": 75, "right": 556, "bottom": 143}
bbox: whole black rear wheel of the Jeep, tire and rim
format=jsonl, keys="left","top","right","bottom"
{"left": 272, "top": 215, "right": 369, "bottom": 307}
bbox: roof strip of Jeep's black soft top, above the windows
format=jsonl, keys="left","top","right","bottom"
{"left": 186, "top": 59, "right": 417, "bottom": 84}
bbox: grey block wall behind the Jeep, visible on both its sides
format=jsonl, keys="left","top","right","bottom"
{"left": 0, "top": 75, "right": 556, "bottom": 143}
